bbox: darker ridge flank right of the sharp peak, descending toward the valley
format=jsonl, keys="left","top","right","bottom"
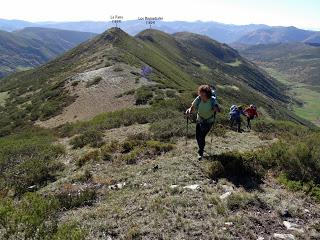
{"left": 137, "top": 30, "right": 307, "bottom": 124}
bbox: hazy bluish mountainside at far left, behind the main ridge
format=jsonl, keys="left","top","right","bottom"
{"left": 0, "top": 27, "right": 96, "bottom": 77}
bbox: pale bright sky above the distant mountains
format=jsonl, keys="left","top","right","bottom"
{"left": 0, "top": 0, "right": 320, "bottom": 30}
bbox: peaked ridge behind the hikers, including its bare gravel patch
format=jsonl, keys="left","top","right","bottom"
{"left": 0, "top": 28, "right": 312, "bottom": 133}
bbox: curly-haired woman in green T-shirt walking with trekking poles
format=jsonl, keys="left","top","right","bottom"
{"left": 186, "top": 85, "right": 220, "bottom": 160}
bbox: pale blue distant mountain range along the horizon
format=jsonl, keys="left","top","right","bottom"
{"left": 0, "top": 19, "right": 320, "bottom": 44}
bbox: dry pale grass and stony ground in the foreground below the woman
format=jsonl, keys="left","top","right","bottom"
{"left": 37, "top": 125, "right": 319, "bottom": 239}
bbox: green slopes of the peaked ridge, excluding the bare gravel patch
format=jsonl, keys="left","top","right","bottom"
{"left": 0, "top": 29, "right": 310, "bottom": 136}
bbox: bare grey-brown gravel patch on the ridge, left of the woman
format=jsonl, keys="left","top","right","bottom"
{"left": 37, "top": 64, "right": 153, "bottom": 128}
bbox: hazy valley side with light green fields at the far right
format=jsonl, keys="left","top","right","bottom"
{"left": 240, "top": 43, "right": 320, "bottom": 124}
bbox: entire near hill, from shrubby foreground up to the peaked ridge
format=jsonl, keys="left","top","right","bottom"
{"left": 0, "top": 28, "right": 320, "bottom": 240}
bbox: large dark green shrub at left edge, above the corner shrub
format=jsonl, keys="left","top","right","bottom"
{"left": 0, "top": 128, "right": 65, "bottom": 195}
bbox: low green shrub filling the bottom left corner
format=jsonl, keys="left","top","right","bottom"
{"left": 0, "top": 193, "right": 86, "bottom": 240}
